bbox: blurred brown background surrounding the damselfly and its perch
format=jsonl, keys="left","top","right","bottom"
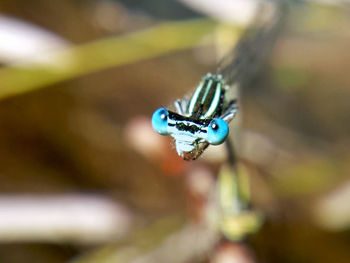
{"left": 0, "top": 0, "right": 350, "bottom": 263}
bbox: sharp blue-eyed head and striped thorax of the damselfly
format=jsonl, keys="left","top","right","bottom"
{"left": 152, "top": 73, "right": 237, "bottom": 160}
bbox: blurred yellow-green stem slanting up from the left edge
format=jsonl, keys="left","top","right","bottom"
{"left": 0, "top": 20, "right": 219, "bottom": 99}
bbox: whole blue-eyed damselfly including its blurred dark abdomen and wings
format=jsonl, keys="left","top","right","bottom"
{"left": 152, "top": 4, "right": 280, "bottom": 160}
